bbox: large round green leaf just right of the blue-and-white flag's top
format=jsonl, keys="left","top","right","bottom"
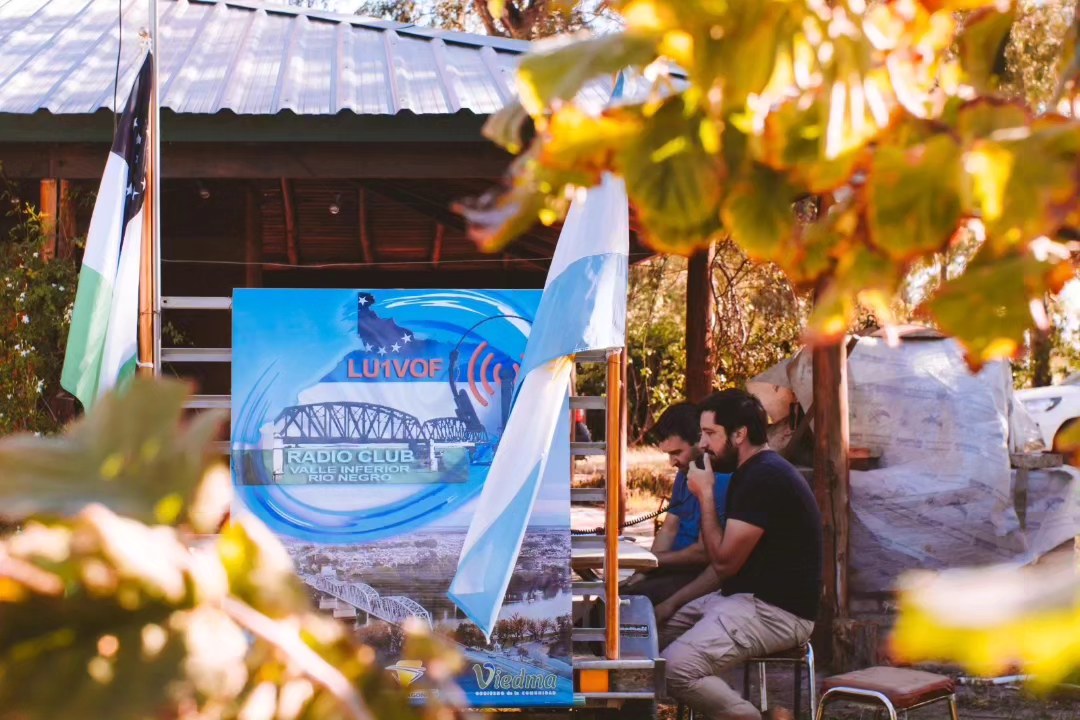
{"left": 616, "top": 97, "right": 726, "bottom": 255}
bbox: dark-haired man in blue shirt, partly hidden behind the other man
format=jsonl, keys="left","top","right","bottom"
{"left": 623, "top": 403, "right": 731, "bottom": 616}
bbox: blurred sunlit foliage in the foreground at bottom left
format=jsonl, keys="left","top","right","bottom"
{"left": 0, "top": 381, "right": 459, "bottom": 720}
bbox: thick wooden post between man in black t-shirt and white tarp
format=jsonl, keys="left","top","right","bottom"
{"left": 813, "top": 342, "right": 849, "bottom": 670}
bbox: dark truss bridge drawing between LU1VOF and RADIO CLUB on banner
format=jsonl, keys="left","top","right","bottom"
{"left": 273, "top": 402, "right": 494, "bottom": 474}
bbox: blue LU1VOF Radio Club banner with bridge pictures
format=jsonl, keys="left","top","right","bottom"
{"left": 231, "top": 289, "right": 573, "bottom": 708}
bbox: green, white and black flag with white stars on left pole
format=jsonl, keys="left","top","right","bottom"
{"left": 60, "top": 53, "right": 153, "bottom": 409}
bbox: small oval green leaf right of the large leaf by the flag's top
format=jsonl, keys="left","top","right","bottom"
{"left": 723, "top": 163, "right": 799, "bottom": 261}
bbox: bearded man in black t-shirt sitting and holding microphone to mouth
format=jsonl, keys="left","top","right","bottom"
{"left": 657, "top": 390, "right": 822, "bottom": 720}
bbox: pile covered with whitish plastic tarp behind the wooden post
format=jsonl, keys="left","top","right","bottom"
{"left": 750, "top": 337, "right": 1080, "bottom": 594}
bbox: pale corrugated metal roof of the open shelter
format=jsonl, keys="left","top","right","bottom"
{"left": 0, "top": 0, "right": 557, "bottom": 114}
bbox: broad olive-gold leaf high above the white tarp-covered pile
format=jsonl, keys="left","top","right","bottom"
{"left": 866, "top": 135, "right": 963, "bottom": 261}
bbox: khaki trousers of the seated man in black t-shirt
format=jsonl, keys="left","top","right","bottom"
{"left": 660, "top": 593, "right": 813, "bottom": 720}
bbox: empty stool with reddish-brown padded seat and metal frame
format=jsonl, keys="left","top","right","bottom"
{"left": 815, "top": 667, "right": 960, "bottom": 720}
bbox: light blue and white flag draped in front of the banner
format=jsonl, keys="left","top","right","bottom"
{"left": 448, "top": 176, "right": 630, "bottom": 637}
